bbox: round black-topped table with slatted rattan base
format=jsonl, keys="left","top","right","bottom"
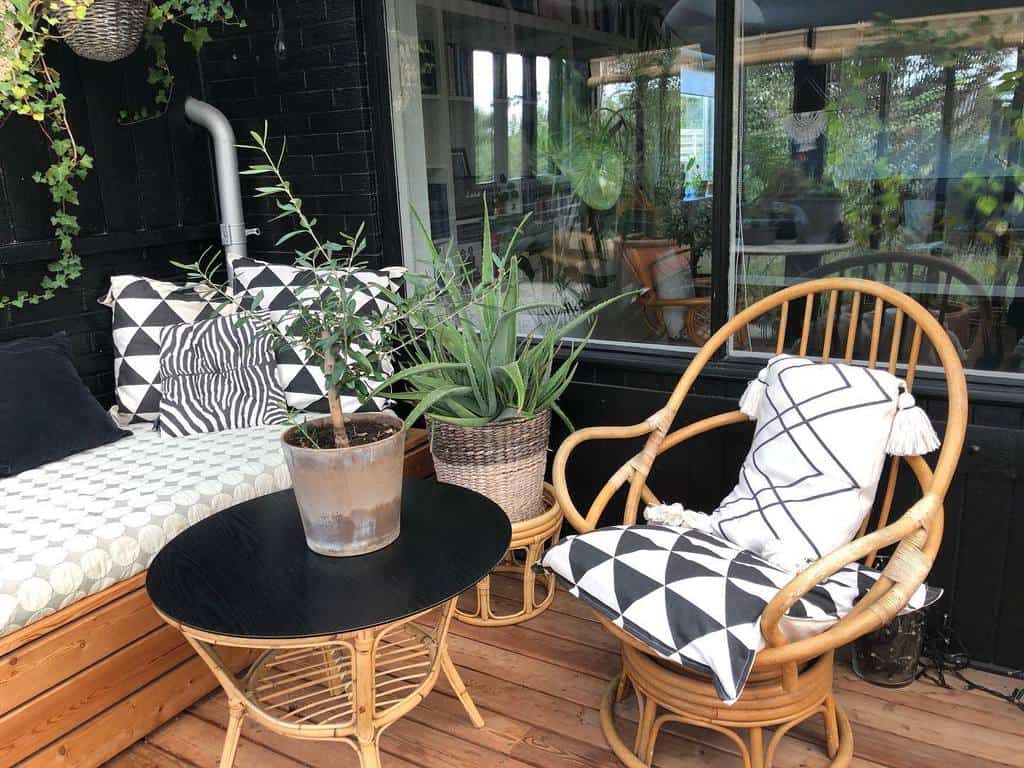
{"left": 146, "top": 480, "right": 511, "bottom": 768}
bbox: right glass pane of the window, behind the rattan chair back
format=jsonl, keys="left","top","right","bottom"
{"left": 733, "top": 0, "right": 1024, "bottom": 374}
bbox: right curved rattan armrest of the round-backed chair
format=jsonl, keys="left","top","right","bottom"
{"left": 755, "top": 494, "right": 941, "bottom": 669}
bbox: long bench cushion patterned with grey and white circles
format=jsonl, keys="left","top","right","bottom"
{"left": 0, "top": 425, "right": 291, "bottom": 635}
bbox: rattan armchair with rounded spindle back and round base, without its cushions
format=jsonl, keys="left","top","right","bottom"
{"left": 553, "top": 278, "right": 967, "bottom": 768}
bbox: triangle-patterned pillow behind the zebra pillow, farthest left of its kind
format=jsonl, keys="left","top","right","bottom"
{"left": 99, "top": 274, "right": 233, "bottom": 423}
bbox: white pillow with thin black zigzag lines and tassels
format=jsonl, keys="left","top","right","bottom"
{"left": 704, "top": 354, "right": 938, "bottom": 568}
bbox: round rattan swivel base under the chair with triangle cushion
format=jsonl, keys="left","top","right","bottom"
{"left": 601, "top": 617, "right": 853, "bottom": 768}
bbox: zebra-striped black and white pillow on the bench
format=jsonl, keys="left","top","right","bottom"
{"left": 159, "top": 314, "right": 287, "bottom": 437}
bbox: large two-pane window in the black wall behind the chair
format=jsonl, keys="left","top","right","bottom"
{"left": 388, "top": 0, "right": 1024, "bottom": 377}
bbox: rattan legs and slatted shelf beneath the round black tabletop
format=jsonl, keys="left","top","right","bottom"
{"left": 172, "top": 599, "right": 483, "bottom": 768}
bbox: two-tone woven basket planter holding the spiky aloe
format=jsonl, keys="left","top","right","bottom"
{"left": 427, "top": 411, "right": 551, "bottom": 522}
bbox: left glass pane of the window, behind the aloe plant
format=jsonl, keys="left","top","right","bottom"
{"left": 389, "top": 0, "right": 715, "bottom": 346}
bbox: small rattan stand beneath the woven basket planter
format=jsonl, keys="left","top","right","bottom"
{"left": 455, "top": 483, "right": 562, "bottom": 627}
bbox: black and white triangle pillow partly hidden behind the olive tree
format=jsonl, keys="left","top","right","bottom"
{"left": 232, "top": 258, "right": 397, "bottom": 413}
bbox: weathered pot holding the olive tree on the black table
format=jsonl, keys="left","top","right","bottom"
{"left": 281, "top": 414, "right": 406, "bottom": 557}
